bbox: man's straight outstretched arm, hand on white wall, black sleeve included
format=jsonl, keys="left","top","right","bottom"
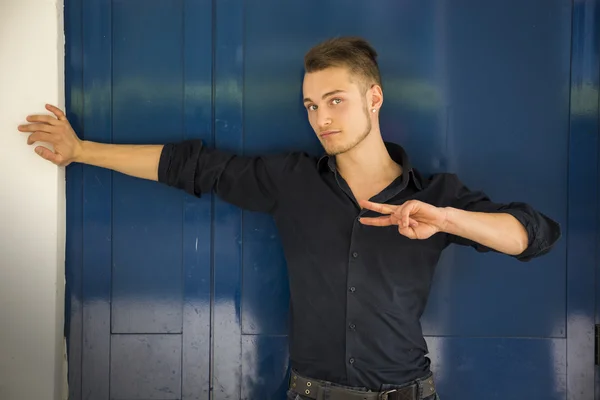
{"left": 19, "top": 105, "right": 302, "bottom": 212}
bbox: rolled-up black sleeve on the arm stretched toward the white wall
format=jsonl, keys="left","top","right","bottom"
{"left": 158, "top": 140, "right": 292, "bottom": 213}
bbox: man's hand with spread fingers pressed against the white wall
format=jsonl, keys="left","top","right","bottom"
{"left": 19, "top": 104, "right": 83, "bottom": 166}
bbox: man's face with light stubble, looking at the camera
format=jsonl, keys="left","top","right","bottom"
{"left": 303, "top": 67, "right": 371, "bottom": 155}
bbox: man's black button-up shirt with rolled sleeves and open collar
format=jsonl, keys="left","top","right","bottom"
{"left": 158, "top": 140, "right": 560, "bottom": 390}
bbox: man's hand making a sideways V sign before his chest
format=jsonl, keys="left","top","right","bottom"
{"left": 359, "top": 200, "right": 448, "bottom": 239}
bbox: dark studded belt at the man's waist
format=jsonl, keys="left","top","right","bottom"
{"left": 290, "top": 371, "right": 435, "bottom": 400}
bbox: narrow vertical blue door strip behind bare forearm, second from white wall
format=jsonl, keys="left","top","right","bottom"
{"left": 81, "top": 0, "right": 112, "bottom": 400}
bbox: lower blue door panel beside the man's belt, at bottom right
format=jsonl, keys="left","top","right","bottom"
{"left": 427, "top": 337, "right": 568, "bottom": 400}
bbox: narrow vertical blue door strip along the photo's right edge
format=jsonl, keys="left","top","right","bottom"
{"left": 566, "top": 0, "right": 600, "bottom": 400}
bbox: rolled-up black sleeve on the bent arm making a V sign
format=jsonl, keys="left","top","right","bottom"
{"left": 442, "top": 174, "right": 561, "bottom": 261}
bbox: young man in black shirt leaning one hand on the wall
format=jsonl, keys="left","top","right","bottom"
{"left": 19, "top": 37, "right": 560, "bottom": 400}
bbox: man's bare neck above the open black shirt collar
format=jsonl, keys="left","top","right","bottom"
{"left": 336, "top": 132, "right": 402, "bottom": 184}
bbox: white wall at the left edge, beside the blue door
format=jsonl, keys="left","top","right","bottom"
{"left": 0, "top": 0, "right": 67, "bottom": 400}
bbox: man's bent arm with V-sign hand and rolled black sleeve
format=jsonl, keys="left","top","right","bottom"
{"left": 361, "top": 174, "right": 561, "bottom": 261}
